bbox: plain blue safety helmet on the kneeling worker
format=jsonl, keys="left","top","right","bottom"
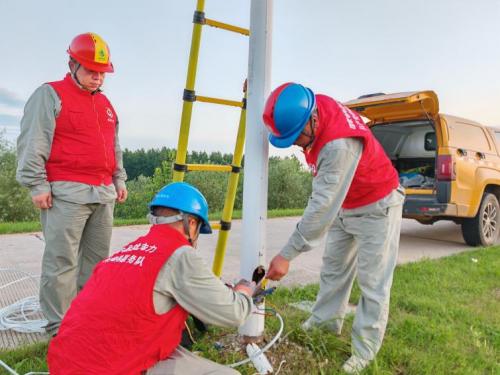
{"left": 149, "top": 182, "right": 212, "bottom": 234}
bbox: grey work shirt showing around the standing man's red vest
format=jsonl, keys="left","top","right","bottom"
{"left": 16, "top": 84, "right": 127, "bottom": 204}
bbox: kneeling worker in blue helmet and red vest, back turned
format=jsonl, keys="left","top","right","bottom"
{"left": 48, "top": 182, "right": 255, "bottom": 375}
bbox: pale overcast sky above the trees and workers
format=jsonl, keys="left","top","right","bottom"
{"left": 0, "top": 0, "right": 500, "bottom": 159}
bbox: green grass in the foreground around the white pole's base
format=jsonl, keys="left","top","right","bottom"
{"left": 0, "top": 247, "right": 500, "bottom": 375}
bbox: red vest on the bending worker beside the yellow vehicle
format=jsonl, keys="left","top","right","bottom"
{"left": 304, "top": 95, "right": 399, "bottom": 209}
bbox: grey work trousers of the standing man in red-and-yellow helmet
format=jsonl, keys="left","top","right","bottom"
{"left": 40, "top": 197, "right": 114, "bottom": 335}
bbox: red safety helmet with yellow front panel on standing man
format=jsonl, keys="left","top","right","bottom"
{"left": 67, "top": 33, "right": 114, "bottom": 73}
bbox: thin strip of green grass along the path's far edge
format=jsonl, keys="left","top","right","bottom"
{"left": 0, "top": 208, "right": 304, "bottom": 234}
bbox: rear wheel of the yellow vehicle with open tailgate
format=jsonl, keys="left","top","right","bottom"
{"left": 462, "top": 193, "right": 500, "bottom": 246}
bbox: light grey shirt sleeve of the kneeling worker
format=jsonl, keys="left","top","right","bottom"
{"left": 153, "top": 246, "right": 253, "bottom": 327}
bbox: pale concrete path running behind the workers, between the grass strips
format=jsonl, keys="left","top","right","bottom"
{"left": 0, "top": 218, "right": 482, "bottom": 349}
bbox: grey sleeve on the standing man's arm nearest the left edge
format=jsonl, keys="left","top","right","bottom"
{"left": 16, "top": 85, "right": 61, "bottom": 203}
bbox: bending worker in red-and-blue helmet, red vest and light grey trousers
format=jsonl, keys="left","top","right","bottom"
{"left": 263, "top": 83, "right": 404, "bottom": 373}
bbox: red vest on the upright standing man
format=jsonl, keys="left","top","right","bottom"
{"left": 45, "top": 74, "right": 117, "bottom": 185}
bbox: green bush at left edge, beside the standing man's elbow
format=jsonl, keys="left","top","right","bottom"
{"left": 0, "top": 134, "right": 39, "bottom": 222}
